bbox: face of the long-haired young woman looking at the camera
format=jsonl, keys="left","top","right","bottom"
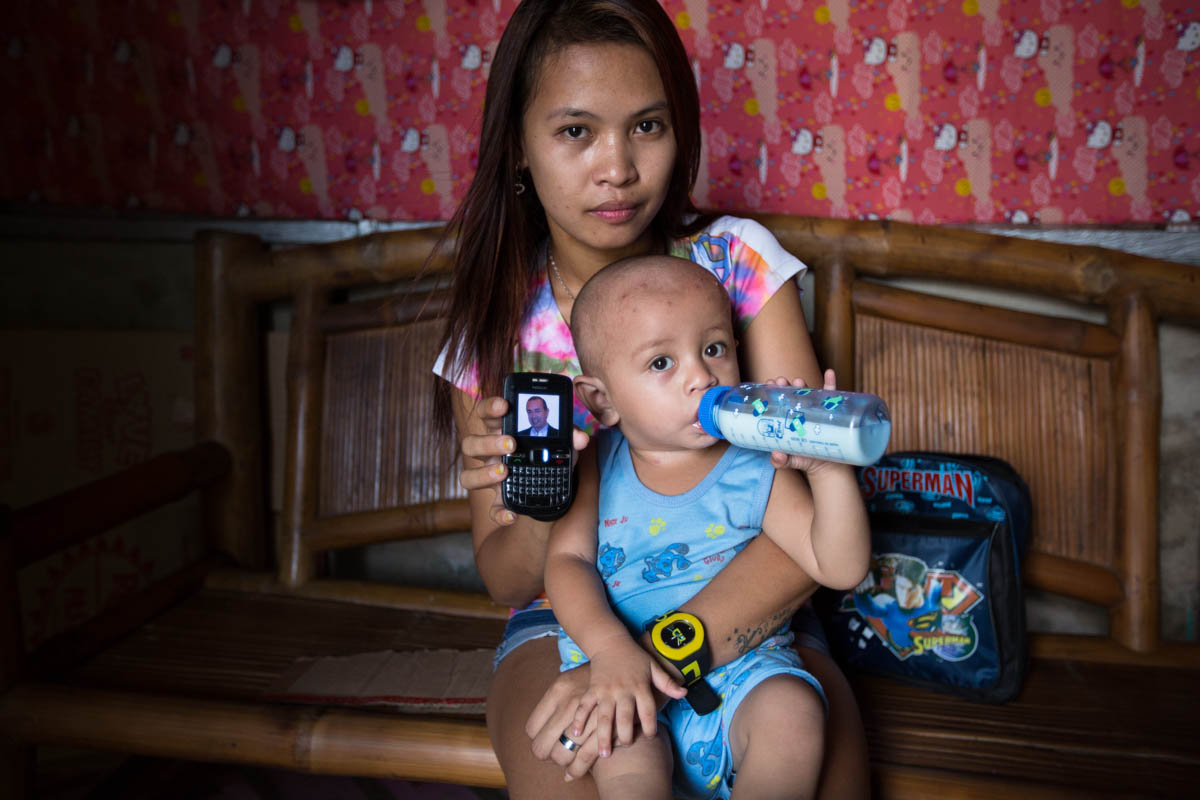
{"left": 522, "top": 44, "right": 676, "bottom": 263}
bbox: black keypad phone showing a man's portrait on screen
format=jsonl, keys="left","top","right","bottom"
{"left": 500, "top": 372, "right": 575, "bottom": 522}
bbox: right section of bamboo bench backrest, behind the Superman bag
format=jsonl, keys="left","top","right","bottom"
{"left": 764, "top": 218, "right": 1200, "bottom": 652}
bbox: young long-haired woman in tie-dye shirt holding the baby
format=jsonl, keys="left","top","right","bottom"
{"left": 436, "top": 0, "right": 869, "bottom": 800}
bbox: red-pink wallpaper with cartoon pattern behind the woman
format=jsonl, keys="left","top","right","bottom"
{"left": 0, "top": 0, "right": 1200, "bottom": 223}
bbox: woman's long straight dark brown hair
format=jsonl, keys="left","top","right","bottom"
{"left": 436, "top": 0, "right": 704, "bottom": 432}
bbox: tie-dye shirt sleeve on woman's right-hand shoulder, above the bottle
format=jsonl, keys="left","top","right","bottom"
{"left": 672, "top": 216, "right": 808, "bottom": 333}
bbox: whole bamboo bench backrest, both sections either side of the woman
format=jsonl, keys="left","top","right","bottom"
{"left": 197, "top": 217, "right": 1200, "bottom": 651}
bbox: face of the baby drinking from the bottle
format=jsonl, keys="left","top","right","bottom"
{"left": 604, "top": 275, "right": 738, "bottom": 451}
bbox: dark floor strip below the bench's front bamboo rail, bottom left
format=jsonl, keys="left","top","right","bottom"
{"left": 37, "top": 748, "right": 508, "bottom": 800}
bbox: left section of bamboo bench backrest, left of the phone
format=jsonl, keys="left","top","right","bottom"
{"left": 197, "top": 229, "right": 460, "bottom": 587}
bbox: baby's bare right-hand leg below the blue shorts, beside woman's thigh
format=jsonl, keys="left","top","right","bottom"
{"left": 730, "top": 675, "right": 826, "bottom": 800}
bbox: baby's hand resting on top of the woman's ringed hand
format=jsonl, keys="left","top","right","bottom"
{"left": 569, "top": 637, "right": 688, "bottom": 758}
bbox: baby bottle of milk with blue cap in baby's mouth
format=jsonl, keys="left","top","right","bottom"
{"left": 700, "top": 384, "right": 892, "bottom": 467}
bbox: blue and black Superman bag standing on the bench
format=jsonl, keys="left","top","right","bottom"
{"left": 816, "top": 452, "right": 1031, "bottom": 703}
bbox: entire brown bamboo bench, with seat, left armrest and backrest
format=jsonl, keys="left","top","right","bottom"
{"left": 0, "top": 217, "right": 1200, "bottom": 798}
